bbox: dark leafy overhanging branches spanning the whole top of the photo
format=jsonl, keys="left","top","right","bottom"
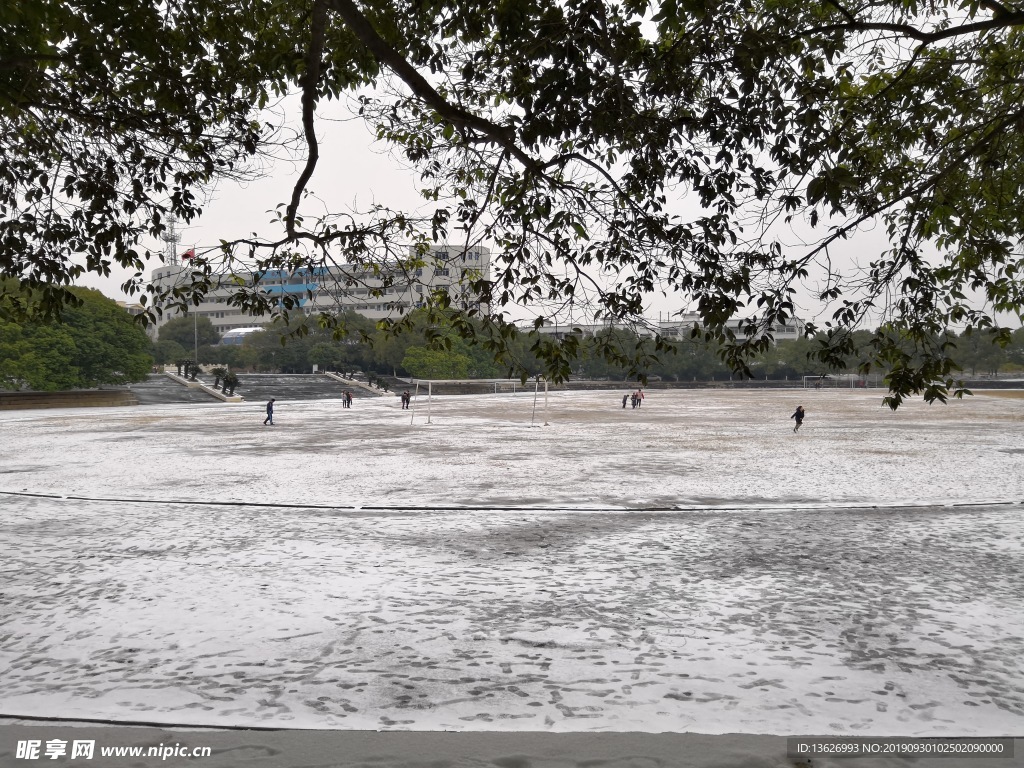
{"left": 0, "top": 0, "right": 1024, "bottom": 407}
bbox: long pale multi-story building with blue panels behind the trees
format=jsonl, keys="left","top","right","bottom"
{"left": 152, "top": 237, "right": 490, "bottom": 334}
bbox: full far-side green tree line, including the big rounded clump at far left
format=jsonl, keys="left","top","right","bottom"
{"left": 0, "top": 288, "right": 1024, "bottom": 391}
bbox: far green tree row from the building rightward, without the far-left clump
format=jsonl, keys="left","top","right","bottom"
{"left": 154, "top": 313, "right": 1024, "bottom": 381}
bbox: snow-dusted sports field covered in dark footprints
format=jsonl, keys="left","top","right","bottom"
{"left": 0, "top": 390, "right": 1024, "bottom": 735}
